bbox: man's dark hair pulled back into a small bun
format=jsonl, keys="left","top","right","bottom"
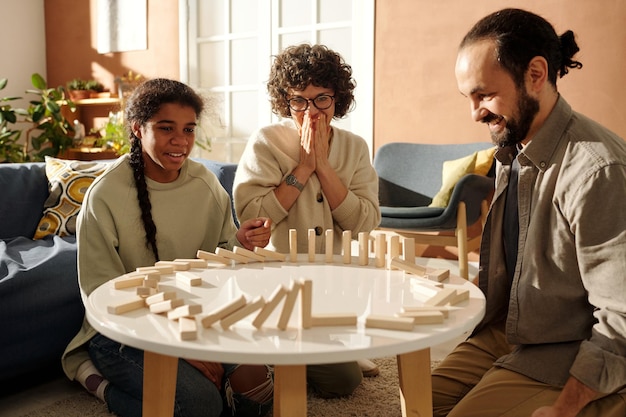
{"left": 459, "top": 9, "right": 583, "bottom": 87}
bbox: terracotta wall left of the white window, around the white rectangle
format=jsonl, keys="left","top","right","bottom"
{"left": 45, "top": 0, "right": 180, "bottom": 91}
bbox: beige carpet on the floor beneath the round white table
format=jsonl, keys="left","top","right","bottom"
{"left": 20, "top": 357, "right": 434, "bottom": 417}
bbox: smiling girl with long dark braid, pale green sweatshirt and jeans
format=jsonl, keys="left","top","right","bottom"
{"left": 63, "top": 79, "right": 273, "bottom": 417}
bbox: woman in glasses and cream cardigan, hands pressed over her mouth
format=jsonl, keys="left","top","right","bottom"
{"left": 234, "top": 44, "right": 380, "bottom": 397}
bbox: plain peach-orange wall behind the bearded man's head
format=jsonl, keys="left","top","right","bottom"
{"left": 374, "top": 0, "right": 626, "bottom": 148}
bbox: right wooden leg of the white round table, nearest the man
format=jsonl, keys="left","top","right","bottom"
{"left": 397, "top": 348, "right": 433, "bottom": 417}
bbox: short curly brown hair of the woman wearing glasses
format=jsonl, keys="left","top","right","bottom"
{"left": 267, "top": 44, "right": 356, "bottom": 119}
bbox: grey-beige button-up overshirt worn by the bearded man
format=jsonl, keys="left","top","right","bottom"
{"left": 479, "top": 98, "right": 626, "bottom": 393}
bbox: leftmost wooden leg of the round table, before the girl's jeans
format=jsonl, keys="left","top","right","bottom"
{"left": 142, "top": 351, "right": 178, "bottom": 417}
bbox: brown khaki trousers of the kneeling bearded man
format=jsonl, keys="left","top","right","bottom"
{"left": 432, "top": 327, "right": 626, "bottom": 417}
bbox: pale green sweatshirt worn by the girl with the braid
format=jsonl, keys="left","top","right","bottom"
{"left": 63, "top": 155, "right": 237, "bottom": 379}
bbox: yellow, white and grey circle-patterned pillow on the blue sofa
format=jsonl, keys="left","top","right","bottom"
{"left": 33, "top": 156, "right": 107, "bottom": 239}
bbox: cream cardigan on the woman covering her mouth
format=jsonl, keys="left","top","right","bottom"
{"left": 233, "top": 119, "right": 380, "bottom": 253}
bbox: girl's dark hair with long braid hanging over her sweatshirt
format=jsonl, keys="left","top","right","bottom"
{"left": 124, "top": 78, "right": 204, "bottom": 261}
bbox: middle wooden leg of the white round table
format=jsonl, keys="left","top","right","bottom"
{"left": 274, "top": 365, "right": 306, "bottom": 417}
